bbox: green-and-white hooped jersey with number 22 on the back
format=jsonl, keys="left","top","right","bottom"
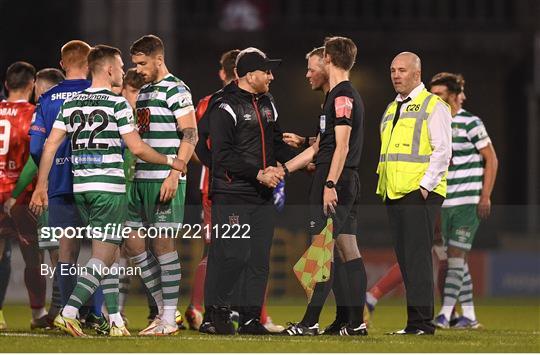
{"left": 53, "top": 88, "right": 135, "bottom": 193}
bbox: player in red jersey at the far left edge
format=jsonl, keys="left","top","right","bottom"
{"left": 0, "top": 62, "right": 48, "bottom": 329}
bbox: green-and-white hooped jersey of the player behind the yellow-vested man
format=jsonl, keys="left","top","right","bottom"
{"left": 443, "top": 109, "right": 491, "bottom": 207}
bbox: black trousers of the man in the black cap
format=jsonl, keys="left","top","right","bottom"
{"left": 205, "top": 194, "right": 275, "bottom": 320}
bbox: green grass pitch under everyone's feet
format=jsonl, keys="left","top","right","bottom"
{"left": 0, "top": 298, "right": 540, "bottom": 353}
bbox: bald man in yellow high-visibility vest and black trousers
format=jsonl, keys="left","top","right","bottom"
{"left": 377, "top": 52, "right": 452, "bottom": 335}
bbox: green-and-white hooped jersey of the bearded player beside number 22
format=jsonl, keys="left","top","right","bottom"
{"left": 135, "top": 74, "right": 194, "bottom": 182}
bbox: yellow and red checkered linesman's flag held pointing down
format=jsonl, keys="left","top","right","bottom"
{"left": 293, "top": 218, "right": 334, "bottom": 302}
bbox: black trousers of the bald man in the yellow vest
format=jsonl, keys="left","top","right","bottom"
{"left": 386, "top": 190, "right": 444, "bottom": 333}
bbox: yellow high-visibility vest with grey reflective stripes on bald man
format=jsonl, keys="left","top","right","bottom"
{"left": 377, "top": 89, "right": 448, "bottom": 200}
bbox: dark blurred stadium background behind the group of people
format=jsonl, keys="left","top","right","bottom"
{"left": 0, "top": 0, "right": 540, "bottom": 247}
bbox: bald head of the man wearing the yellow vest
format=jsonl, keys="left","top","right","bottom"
{"left": 390, "top": 52, "right": 422, "bottom": 97}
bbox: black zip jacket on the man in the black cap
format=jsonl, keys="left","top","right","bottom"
{"left": 208, "top": 83, "right": 295, "bottom": 199}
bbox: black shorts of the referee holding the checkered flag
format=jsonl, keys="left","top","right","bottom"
{"left": 308, "top": 165, "right": 360, "bottom": 238}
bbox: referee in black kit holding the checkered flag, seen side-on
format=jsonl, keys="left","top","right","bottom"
{"left": 283, "top": 37, "right": 367, "bottom": 336}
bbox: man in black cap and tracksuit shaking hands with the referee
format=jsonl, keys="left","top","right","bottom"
{"left": 205, "top": 48, "right": 295, "bottom": 335}
